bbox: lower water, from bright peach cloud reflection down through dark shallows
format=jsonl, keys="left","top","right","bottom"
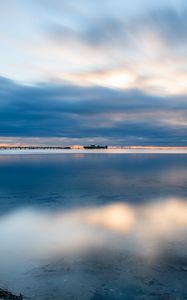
{"left": 0, "top": 199, "right": 187, "bottom": 300}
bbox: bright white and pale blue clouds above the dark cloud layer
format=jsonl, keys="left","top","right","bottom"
{"left": 0, "top": 0, "right": 187, "bottom": 96}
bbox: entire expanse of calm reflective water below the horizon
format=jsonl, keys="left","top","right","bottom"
{"left": 0, "top": 153, "right": 187, "bottom": 300}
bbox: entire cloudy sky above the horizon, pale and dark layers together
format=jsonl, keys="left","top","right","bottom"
{"left": 0, "top": 0, "right": 187, "bottom": 145}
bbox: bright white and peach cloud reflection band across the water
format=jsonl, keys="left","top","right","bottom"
{"left": 0, "top": 199, "right": 187, "bottom": 258}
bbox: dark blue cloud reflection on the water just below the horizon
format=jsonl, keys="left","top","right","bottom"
{"left": 0, "top": 154, "right": 187, "bottom": 214}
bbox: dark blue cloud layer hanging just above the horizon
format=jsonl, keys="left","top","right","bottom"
{"left": 0, "top": 78, "right": 187, "bottom": 145}
